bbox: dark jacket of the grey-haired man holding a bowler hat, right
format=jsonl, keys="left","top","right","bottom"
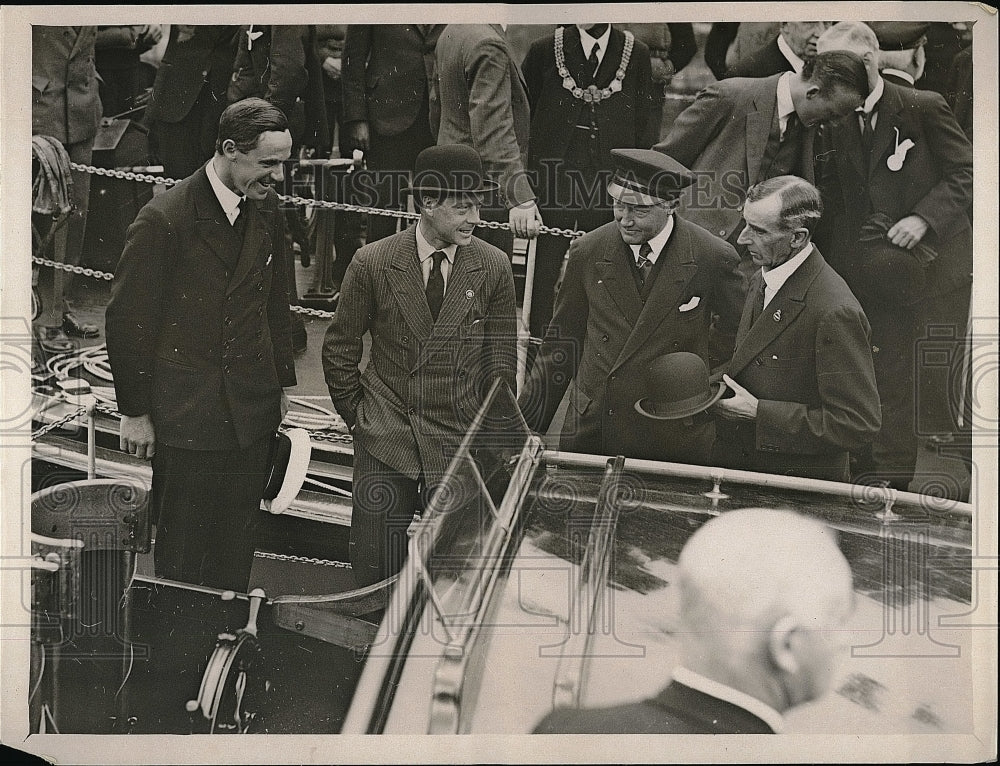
{"left": 716, "top": 249, "right": 882, "bottom": 481}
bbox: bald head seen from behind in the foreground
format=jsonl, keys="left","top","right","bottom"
{"left": 678, "top": 509, "right": 854, "bottom": 710}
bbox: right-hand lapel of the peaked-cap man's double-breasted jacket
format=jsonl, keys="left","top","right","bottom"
{"left": 612, "top": 216, "right": 705, "bottom": 369}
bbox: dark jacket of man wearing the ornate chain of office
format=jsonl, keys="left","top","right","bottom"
{"left": 522, "top": 25, "right": 659, "bottom": 178}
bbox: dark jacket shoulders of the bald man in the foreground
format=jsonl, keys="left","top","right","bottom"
{"left": 533, "top": 681, "right": 774, "bottom": 734}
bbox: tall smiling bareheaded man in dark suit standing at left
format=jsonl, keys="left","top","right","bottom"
{"left": 107, "top": 99, "right": 295, "bottom": 590}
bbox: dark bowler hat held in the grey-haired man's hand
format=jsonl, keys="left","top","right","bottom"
{"left": 635, "top": 351, "right": 726, "bottom": 420}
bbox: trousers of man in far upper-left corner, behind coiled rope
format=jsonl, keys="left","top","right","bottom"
{"left": 32, "top": 137, "right": 94, "bottom": 327}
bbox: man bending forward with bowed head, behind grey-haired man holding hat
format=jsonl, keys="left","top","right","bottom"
{"left": 653, "top": 52, "right": 868, "bottom": 255}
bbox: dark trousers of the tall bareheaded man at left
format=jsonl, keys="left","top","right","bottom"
{"left": 151, "top": 438, "right": 271, "bottom": 591}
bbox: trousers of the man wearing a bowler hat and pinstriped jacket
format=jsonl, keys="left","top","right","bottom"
{"left": 351, "top": 441, "right": 426, "bottom": 588}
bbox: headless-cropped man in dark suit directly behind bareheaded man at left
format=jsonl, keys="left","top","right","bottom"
{"left": 146, "top": 24, "right": 239, "bottom": 178}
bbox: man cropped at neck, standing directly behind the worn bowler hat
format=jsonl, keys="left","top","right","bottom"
{"left": 340, "top": 24, "right": 445, "bottom": 242}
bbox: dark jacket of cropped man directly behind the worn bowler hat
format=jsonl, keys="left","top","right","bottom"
{"left": 341, "top": 24, "right": 445, "bottom": 136}
